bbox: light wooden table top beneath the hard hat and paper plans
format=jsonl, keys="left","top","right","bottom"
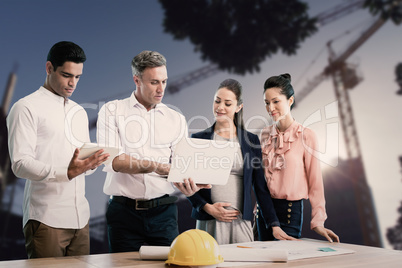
{"left": 0, "top": 241, "right": 402, "bottom": 268}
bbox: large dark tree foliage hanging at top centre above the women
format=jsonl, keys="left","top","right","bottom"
{"left": 159, "top": 0, "right": 317, "bottom": 74}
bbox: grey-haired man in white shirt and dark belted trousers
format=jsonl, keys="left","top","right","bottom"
{"left": 97, "top": 51, "right": 187, "bottom": 252}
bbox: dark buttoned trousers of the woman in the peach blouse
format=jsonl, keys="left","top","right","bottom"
{"left": 256, "top": 198, "right": 303, "bottom": 241}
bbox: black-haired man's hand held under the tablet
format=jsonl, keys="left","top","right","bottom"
{"left": 67, "top": 148, "right": 110, "bottom": 180}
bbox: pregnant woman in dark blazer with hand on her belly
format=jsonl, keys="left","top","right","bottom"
{"left": 175, "top": 79, "right": 293, "bottom": 244}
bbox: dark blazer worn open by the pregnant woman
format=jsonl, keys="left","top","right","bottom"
{"left": 188, "top": 124, "right": 279, "bottom": 227}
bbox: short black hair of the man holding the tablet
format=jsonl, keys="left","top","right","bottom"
{"left": 47, "top": 41, "right": 87, "bottom": 70}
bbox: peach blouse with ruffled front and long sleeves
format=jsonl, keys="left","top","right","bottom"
{"left": 260, "top": 121, "right": 327, "bottom": 228}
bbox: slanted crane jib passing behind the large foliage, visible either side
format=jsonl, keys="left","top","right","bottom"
{"left": 166, "top": 0, "right": 365, "bottom": 94}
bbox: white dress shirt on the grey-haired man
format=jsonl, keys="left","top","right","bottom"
{"left": 97, "top": 93, "right": 187, "bottom": 199}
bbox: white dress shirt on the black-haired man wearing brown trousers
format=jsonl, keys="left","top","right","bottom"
{"left": 7, "top": 87, "right": 90, "bottom": 229}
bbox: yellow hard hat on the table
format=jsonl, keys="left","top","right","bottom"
{"left": 166, "top": 229, "right": 223, "bottom": 266}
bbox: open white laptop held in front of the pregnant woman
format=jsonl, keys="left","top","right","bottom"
{"left": 167, "top": 138, "right": 239, "bottom": 185}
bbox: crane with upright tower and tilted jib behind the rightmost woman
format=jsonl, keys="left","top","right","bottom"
{"left": 296, "top": 10, "right": 396, "bottom": 246}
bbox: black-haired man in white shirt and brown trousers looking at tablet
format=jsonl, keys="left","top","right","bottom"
{"left": 7, "top": 41, "right": 109, "bottom": 258}
